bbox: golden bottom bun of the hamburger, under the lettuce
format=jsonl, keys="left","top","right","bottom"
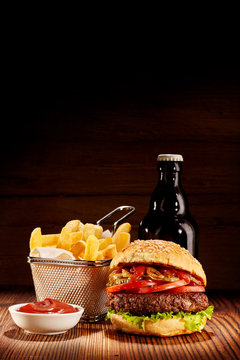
{"left": 110, "top": 314, "right": 207, "bottom": 336}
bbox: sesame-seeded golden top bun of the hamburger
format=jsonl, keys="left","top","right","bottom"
{"left": 110, "top": 240, "right": 207, "bottom": 286}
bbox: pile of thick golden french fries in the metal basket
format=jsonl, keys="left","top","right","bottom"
{"left": 29, "top": 220, "right": 131, "bottom": 261}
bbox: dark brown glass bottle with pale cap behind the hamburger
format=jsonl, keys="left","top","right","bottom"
{"left": 138, "top": 154, "right": 198, "bottom": 258}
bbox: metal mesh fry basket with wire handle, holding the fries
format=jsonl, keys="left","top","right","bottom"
{"left": 28, "top": 206, "right": 135, "bottom": 322}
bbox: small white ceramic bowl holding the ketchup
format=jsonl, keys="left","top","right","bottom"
{"left": 8, "top": 303, "right": 84, "bottom": 335}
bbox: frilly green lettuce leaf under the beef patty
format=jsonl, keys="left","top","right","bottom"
{"left": 106, "top": 306, "right": 214, "bottom": 332}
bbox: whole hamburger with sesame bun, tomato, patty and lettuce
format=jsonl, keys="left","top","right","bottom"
{"left": 106, "top": 240, "right": 213, "bottom": 336}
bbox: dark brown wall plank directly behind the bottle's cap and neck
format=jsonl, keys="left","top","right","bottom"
{"left": 0, "top": 139, "right": 239, "bottom": 196}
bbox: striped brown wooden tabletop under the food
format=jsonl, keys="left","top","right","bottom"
{"left": 0, "top": 288, "right": 240, "bottom": 360}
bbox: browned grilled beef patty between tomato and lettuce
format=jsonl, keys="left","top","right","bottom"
{"left": 106, "top": 292, "right": 208, "bottom": 315}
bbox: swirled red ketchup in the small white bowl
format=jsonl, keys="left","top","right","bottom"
{"left": 18, "top": 298, "right": 78, "bottom": 314}
